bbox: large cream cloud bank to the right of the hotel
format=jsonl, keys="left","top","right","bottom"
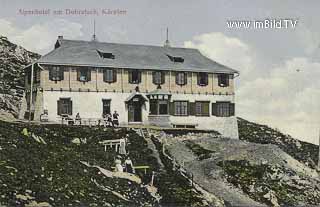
{"left": 185, "top": 33, "right": 320, "bottom": 143}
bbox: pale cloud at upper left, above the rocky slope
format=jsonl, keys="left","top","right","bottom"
{"left": 0, "top": 19, "right": 83, "bottom": 54}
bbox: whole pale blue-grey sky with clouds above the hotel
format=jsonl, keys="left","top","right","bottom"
{"left": 0, "top": 0, "right": 320, "bottom": 144}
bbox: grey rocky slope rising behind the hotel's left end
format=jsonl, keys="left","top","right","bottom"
{"left": 0, "top": 36, "right": 40, "bottom": 115}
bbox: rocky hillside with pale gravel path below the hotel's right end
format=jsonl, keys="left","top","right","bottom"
{"left": 155, "top": 119, "right": 320, "bottom": 206}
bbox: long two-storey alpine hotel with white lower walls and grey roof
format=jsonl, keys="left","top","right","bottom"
{"left": 20, "top": 36, "right": 238, "bottom": 138}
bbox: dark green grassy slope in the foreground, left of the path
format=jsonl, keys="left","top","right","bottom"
{"left": 0, "top": 121, "right": 214, "bottom": 207}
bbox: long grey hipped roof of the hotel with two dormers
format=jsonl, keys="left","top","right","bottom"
{"left": 37, "top": 39, "right": 238, "bottom": 73}
